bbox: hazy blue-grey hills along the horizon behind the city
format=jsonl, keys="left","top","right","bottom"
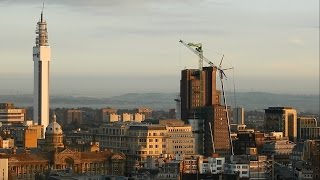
{"left": 0, "top": 92, "right": 319, "bottom": 114}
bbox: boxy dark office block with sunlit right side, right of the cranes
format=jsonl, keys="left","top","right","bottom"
{"left": 264, "top": 107, "right": 297, "bottom": 142}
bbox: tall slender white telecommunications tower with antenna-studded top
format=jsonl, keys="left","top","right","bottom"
{"left": 33, "top": 8, "right": 51, "bottom": 138}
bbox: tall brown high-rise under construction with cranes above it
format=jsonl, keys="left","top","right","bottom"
{"left": 180, "top": 67, "right": 230, "bottom": 156}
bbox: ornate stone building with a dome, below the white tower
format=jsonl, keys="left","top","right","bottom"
{"left": 0, "top": 118, "right": 126, "bottom": 180}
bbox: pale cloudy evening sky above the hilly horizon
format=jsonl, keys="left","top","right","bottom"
{"left": 0, "top": 0, "right": 319, "bottom": 96}
